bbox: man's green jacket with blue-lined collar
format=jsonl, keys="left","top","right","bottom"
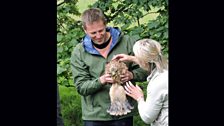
{"left": 71, "top": 27, "right": 147, "bottom": 121}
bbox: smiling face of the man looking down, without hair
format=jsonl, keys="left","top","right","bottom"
{"left": 84, "top": 20, "right": 106, "bottom": 44}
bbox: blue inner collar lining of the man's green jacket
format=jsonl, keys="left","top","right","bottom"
{"left": 82, "top": 27, "right": 121, "bottom": 55}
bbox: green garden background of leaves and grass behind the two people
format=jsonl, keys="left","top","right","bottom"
{"left": 57, "top": 0, "right": 168, "bottom": 126}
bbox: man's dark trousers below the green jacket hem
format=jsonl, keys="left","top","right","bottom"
{"left": 84, "top": 117, "right": 133, "bottom": 126}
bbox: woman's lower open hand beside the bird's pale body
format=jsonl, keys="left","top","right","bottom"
{"left": 124, "top": 81, "right": 144, "bottom": 101}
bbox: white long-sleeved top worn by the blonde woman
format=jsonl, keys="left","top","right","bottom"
{"left": 138, "top": 69, "right": 168, "bottom": 126}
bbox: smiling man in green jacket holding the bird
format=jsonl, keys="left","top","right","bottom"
{"left": 71, "top": 8, "right": 147, "bottom": 126}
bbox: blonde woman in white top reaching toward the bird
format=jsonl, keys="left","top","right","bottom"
{"left": 113, "top": 39, "right": 168, "bottom": 126}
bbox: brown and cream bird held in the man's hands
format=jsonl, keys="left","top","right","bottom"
{"left": 105, "top": 60, "right": 134, "bottom": 116}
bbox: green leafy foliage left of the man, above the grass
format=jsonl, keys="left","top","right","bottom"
{"left": 57, "top": 0, "right": 84, "bottom": 86}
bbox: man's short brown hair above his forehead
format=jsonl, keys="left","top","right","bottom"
{"left": 81, "top": 8, "right": 107, "bottom": 29}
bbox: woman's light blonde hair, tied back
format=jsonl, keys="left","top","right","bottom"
{"left": 133, "top": 39, "right": 168, "bottom": 72}
